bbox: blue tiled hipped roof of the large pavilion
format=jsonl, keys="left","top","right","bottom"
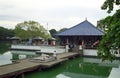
{"left": 56, "top": 20, "right": 104, "bottom": 36}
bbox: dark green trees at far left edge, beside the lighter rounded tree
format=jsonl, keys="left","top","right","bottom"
{"left": 0, "top": 27, "right": 14, "bottom": 40}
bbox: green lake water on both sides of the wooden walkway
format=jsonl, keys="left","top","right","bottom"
{"left": 0, "top": 51, "right": 120, "bottom": 78}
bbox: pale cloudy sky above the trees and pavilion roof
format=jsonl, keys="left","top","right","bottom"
{"left": 0, "top": 0, "right": 115, "bottom": 30}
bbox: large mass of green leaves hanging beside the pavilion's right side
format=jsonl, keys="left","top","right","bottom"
{"left": 98, "top": 10, "right": 120, "bottom": 61}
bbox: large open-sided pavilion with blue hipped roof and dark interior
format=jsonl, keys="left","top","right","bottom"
{"left": 56, "top": 19, "right": 104, "bottom": 51}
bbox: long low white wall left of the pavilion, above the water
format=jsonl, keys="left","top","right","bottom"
{"left": 11, "top": 45, "right": 65, "bottom": 53}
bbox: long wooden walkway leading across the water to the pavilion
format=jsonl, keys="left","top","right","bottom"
{"left": 0, "top": 53, "right": 79, "bottom": 78}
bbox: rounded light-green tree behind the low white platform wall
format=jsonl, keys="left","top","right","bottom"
{"left": 15, "top": 21, "right": 50, "bottom": 39}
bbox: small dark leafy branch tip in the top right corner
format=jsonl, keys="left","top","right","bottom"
{"left": 101, "top": 0, "right": 120, "bottom": 13}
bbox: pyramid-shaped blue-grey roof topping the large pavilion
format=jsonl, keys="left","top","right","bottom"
{"left": 56, "top": 20, "right": 104, "bottom": 35}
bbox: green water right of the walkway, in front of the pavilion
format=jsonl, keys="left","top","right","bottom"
{"left": 25, "top": 58, "right": 120, "bottom": 78}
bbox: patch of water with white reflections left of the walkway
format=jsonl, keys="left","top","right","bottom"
{"left": 0, "top": 51, "right": 37, "bottom": 65}
